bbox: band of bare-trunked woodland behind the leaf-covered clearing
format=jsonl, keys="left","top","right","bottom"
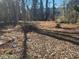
{"left": 0, "top": 0, "right": 79, "bottom": 23}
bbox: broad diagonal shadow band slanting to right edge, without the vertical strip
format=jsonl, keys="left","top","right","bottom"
{"left": 25, "top": 25, "right": 79, "bottom": 45}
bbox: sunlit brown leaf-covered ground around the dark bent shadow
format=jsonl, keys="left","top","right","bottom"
{"left": 0, "top": 22, "right": 79, "bottom": 59}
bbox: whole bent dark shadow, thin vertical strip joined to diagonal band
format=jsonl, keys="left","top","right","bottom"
{"left": 21, "top": 25, "right": 79, "bottom": 59}
